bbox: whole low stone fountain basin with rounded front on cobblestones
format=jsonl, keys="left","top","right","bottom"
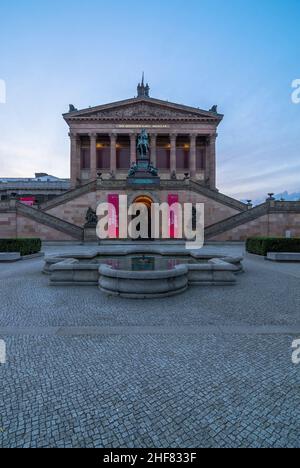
{"left": 43, "top": 247, "right": 243, "bottom": 298}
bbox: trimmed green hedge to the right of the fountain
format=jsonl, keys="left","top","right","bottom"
{"left": 246, "top": 237, "right": 300, "bottom": 256}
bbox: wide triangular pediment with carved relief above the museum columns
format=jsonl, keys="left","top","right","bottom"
{"left": 64, "top": 98, "right": 222, "bottom": 122}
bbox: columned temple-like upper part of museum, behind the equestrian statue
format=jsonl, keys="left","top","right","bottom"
{"left": 64, "top": 77, "right": 223, "bottom": 190}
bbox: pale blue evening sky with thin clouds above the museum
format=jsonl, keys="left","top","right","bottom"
{"left": 0, "top": 0, "right": 300, "bottom": 199}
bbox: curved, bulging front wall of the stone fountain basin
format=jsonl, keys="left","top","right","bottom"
{"left": 99, "top": 265, "right": 188, "bottom": 299}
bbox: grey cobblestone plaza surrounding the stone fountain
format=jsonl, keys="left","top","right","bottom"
{"left": 0, "top": 246, "right": 300, "bottom": 447}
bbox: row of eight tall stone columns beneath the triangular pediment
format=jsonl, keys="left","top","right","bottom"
{"left": 69, "top": 133, "right": 217, "bottom": 189}
